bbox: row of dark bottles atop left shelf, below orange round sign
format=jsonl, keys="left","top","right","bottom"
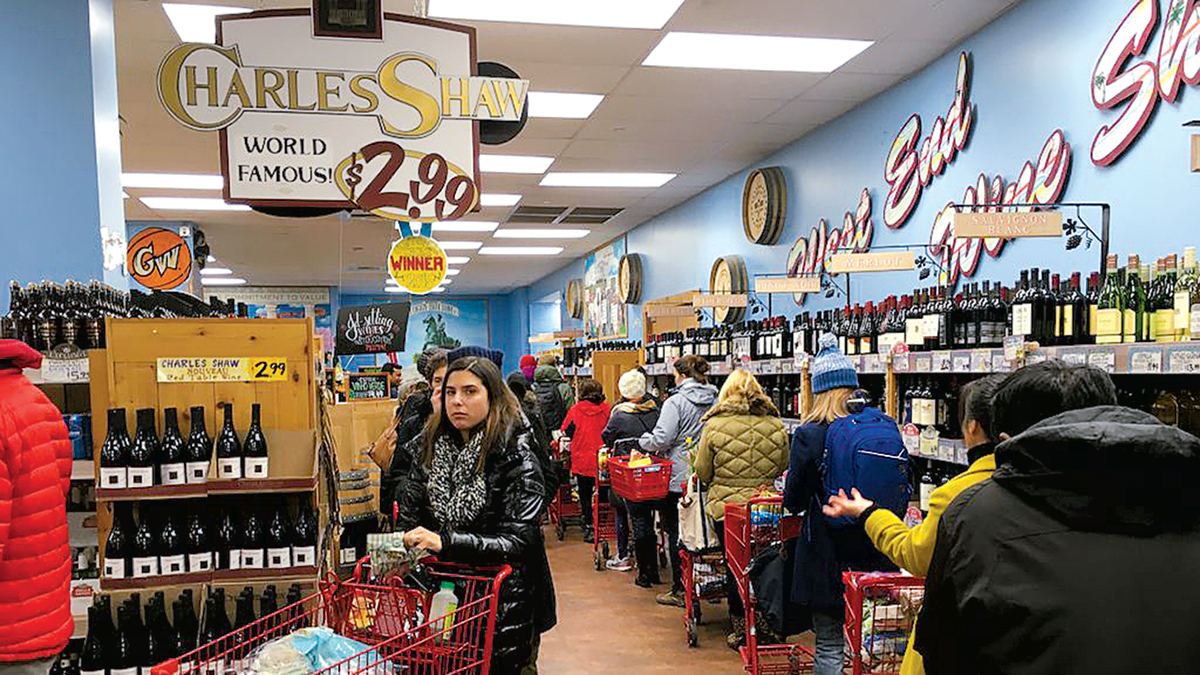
{"left": 0, "top": 280, "right": 258, "bottom": 352}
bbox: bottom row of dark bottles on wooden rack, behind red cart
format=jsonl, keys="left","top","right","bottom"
{"left": 78, "top": 584, "right": 304, "bottom": 675}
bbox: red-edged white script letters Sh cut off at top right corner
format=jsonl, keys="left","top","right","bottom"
{"left": 1091, "top": 0, "right": 1200, "bottom": 166}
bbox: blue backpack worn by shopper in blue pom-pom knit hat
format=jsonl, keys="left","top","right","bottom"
{"left": 821, "top": 408, "right": 912, "bottom": 527}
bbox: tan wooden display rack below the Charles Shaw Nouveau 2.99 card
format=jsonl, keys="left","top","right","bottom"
{"left": 89, "top": 318, "right": 326, "bottom": 592}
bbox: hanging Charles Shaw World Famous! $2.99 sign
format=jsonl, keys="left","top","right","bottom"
{"left": 158, "top": 10, "right": 529, "bottom": 214}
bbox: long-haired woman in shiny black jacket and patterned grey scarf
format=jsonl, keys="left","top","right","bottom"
{"left": 397, "top": 357, "right": 557, "bottom": 675}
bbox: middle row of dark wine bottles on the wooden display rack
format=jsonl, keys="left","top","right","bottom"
{"left": 104, "top": 504, "right": 318, "bottom": 579}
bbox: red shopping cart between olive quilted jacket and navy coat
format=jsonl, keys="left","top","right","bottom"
{"left": 725, "top": 497, "right": 812, "bottom": 675}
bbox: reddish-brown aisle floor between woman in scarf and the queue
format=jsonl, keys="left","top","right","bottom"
{"left": 538, "top": 527, "right": 743, "bottom": 675}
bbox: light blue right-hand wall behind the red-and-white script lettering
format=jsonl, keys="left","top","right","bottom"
{"left": 529, "top": 0, "right": 1200, "bottom": 338}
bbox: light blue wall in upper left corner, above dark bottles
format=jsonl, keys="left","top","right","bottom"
{"left": 0, "top": 0, "right": 124, "bottom": 312}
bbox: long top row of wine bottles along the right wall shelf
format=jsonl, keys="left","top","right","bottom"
{"left": 646, "top": 246, "right": 1200, "bottom": 364}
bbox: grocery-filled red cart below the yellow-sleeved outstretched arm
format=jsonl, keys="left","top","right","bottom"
{"left": 842, "top": 572, "right": 925, "bottom": 675}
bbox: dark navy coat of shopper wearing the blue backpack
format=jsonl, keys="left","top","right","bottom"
{"left": 784, "top": 424, "right": 896, "bottom": 614}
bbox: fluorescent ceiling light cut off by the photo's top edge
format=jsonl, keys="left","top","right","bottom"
{"left": 428, "top": 0, "right": 683, "bottom": 30}
